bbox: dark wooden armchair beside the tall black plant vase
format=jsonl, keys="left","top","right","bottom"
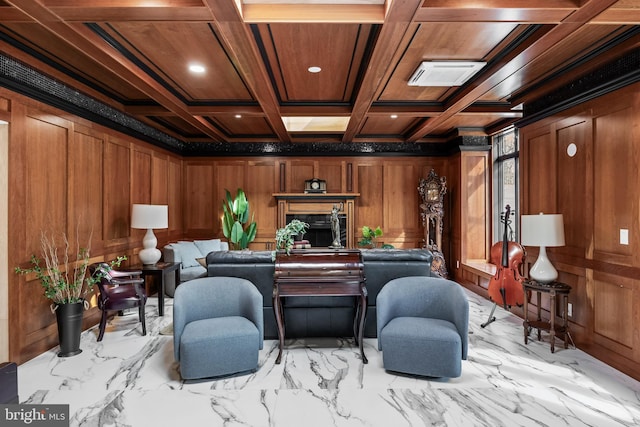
{"left": 89, "top": 262, "right": 147, "bottom": 341}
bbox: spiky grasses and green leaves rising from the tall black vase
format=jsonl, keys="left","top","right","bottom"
{"left": 14, "top": 232, "right": 127, "bottom": 310}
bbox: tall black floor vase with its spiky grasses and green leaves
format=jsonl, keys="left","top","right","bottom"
{"left": 15, "top": 232, "right": 127, "bottom": 357}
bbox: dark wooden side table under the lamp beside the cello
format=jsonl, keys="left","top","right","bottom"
{"left": 522, "top": 280, "right": 571, "bottom": 353}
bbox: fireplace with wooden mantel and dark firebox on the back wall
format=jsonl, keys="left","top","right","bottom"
{"left": 273, "top": 193, "right": 359, "bottom": 248}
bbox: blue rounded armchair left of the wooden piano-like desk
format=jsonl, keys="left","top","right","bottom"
{"left": 173, "top": 277, "right": 264, "bottom": 380}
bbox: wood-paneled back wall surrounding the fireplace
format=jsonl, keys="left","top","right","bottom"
{"left": 184, "top": 157, "right": 446, "bottom": 250}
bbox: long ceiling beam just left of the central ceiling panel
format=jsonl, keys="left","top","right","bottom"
{"left": 204, "top": 0, "right": 291, "bottom": 142}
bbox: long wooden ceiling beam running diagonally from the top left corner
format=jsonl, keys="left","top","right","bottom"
{"left": 1, "top": 0, "right": 226, "bottom": 141}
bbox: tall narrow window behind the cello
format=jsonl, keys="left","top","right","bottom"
{"left": 493, "top": 128, "right": 520, "bottom": 242}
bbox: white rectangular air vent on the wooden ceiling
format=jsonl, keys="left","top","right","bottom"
{"left": 408, "top": 61, "right": 486, "bottom": 86}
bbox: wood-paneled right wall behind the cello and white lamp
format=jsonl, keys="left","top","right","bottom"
{"left": 520, "top": 84, "right": 640, "bottom": 378}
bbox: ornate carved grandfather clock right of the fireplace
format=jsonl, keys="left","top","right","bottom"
{"left": 418, "top": 169, "right": 448, "bottom": 277}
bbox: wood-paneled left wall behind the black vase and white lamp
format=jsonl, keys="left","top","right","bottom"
{"left": 6, "top": 91, "right": 183, "bottom": 363}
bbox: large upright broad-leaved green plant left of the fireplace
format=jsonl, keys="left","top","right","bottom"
{"left": 222, "top": 188, "right": 257, "bottom": 249}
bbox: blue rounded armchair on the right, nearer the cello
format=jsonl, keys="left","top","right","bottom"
{"left": 376, "top": 276, "right": 469, "bottom": 378}
